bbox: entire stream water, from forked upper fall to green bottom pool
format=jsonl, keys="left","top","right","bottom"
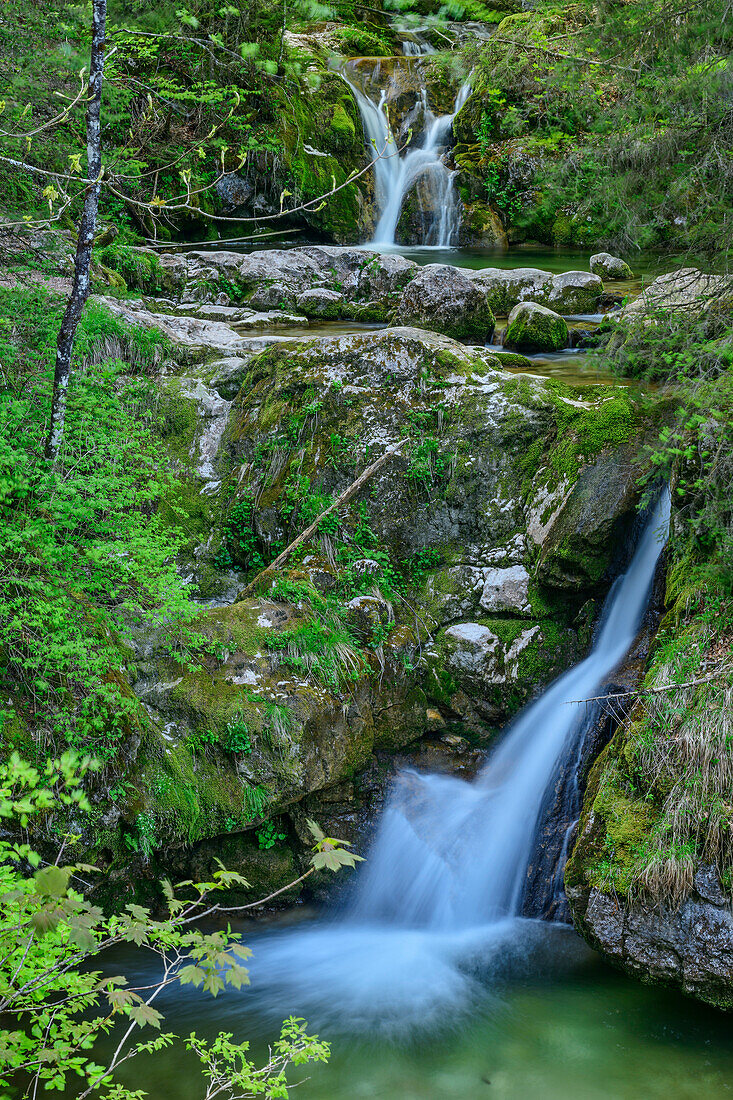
{"left": 111, "top": 58, "right": 717, "bottom": 1100}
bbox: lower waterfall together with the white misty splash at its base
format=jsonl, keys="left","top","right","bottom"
{"left": 245, "top": 492, "right": 670, "bottom": 1032}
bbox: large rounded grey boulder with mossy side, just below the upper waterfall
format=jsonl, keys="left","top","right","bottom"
{"left": 395, "top": 264, "right": 494, "bottom": 343}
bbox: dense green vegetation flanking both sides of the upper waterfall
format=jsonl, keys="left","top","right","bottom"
{"left": 0, "top": 0, "right": 733, "bottom": 253}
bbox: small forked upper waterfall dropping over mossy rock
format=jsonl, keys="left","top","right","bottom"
{"left": 341, "top": 66, "right": 471, "bottom": 249}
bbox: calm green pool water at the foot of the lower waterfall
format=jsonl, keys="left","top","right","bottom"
{"left": 108, "top": 922, "right": 733, "bottom": 1100}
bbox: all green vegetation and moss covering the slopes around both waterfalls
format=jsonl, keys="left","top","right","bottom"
{"left": 0, "top": 0, "right": 733, "bottom": 1086}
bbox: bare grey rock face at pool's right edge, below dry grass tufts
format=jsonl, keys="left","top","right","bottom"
{"left": 568, "top": 867, "right": 733, "bottom": 1009}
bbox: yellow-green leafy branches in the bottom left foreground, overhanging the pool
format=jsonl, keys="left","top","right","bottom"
{"left": 0, "top": 754, "right": 330, "bottom": 1100}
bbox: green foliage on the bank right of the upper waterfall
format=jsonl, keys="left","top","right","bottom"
{"left": 459, "top": 0, "right": 733, "bottom": 253}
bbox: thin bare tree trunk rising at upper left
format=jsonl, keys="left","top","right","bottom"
{"left": 45, "top": 0, "right": 107, "bottom": 462}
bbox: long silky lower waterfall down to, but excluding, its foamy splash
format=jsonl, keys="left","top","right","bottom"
{"left": 349, "top": 494, "right": 669, "bottom": 928}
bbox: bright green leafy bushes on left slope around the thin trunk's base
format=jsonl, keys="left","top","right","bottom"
{"left": 0, "top": 288, "right": 199, "bottom": 758}
